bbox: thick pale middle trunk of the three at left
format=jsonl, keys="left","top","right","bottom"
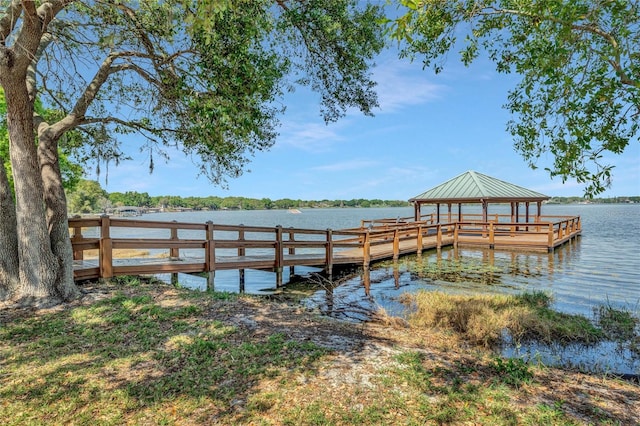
{"left": 3, "top": 79, "right": 60, "bottom": 300}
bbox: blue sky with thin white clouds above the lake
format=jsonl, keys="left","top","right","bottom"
{"left": 90, "top": 52, "right": 640, "bottom": 200}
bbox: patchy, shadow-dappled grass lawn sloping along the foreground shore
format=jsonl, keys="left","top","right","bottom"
{"left": 0, "top": 279, "right": 640, "bottom": 425}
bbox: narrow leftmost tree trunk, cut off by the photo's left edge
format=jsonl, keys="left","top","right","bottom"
{"left": 0, "top": 158, "right": 19, "bottom": 300}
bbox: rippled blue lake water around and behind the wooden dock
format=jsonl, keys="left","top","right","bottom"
{"left": 136, "top": 204, "right": 640, "bottom": 374}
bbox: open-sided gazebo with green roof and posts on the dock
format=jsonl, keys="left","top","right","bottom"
{"left": 409, "top": 171, "right": 550, "bottom": 223}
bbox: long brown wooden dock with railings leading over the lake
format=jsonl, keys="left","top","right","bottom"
{"left": 69, "top": 215, "right": 581, "bottom": 292}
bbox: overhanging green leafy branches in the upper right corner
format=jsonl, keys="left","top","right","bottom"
{"left": 391, "top": 0, "right": 640, "bottom": 196}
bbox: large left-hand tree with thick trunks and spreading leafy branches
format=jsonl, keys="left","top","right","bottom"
{"left": 0, "top": 0, "right": 383, "bottom": 306}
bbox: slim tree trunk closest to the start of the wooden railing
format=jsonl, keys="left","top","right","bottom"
{"left": 38, "top": 131, "right": 79, "bottom": 300}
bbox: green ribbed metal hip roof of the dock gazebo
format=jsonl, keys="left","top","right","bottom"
{"left": 409, "top": 171, "right": 551, "bottom": 203}
